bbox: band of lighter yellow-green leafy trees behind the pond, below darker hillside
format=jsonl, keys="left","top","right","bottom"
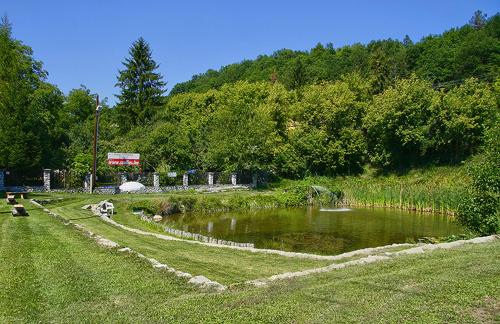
{"left": 116, "top": 73, "right": 500, "bottom": 178}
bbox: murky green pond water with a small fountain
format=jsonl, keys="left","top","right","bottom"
{"left": 165, "top": 208, "right": 462, "bottom": 254}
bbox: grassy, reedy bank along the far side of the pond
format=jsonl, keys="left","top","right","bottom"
{"left": 104, "top": 167, "right": 469, "bottom": 218}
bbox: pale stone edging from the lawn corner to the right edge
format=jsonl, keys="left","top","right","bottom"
{"left": 245, "top": 235, "right": 500, "bottom": 287}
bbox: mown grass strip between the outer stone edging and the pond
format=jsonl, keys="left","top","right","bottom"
{"left": 40, "top": 195, "right": 331, "bottom": 285}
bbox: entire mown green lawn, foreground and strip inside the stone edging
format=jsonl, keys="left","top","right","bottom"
{"left": 0, "top": 196, "right": 500, "bottom": 323}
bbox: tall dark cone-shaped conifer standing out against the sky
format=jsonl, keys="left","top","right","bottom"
{"left": 116, "top": 37, "right": 166, "bottom": 130}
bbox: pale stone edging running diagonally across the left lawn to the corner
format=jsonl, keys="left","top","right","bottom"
{"left": 31, "top": 199, "right": 227, "bottom": 292}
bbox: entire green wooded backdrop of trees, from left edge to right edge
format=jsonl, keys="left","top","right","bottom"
{"left": 0, "top": 12, "right": 500, "bottom": 183}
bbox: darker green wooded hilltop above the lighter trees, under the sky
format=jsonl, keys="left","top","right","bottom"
{"left": 171, "top": 11, "right": 500, "bottom": 94}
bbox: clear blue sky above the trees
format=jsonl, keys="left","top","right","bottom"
{"left": 0, "top": 0, "right": 500, "bottom": 103}
